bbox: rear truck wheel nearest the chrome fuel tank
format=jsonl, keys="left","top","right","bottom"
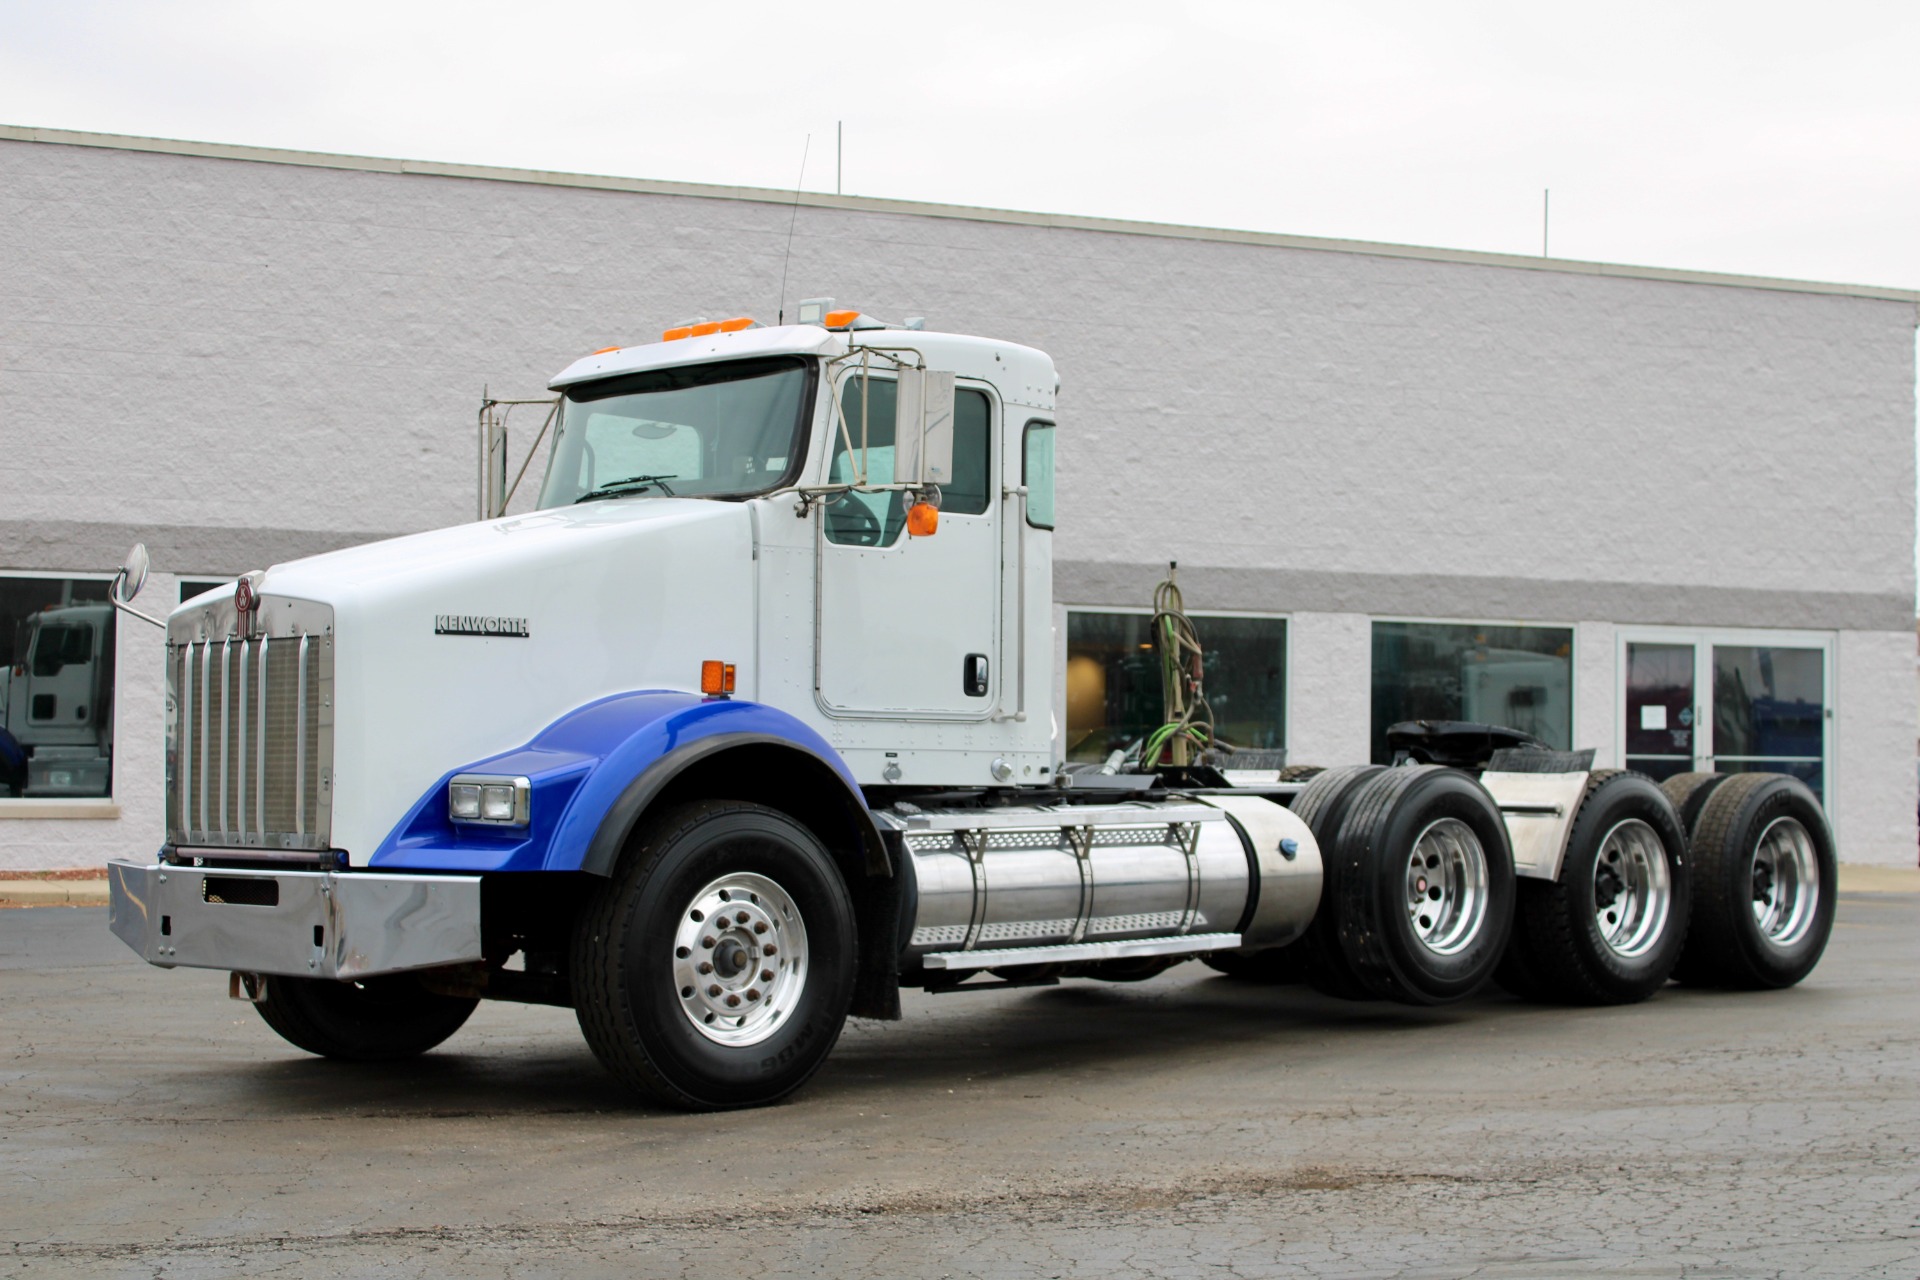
{"left": 1321, "top": 766, "right": 1515, "bottom": 1004}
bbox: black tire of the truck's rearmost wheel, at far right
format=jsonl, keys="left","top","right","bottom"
{"left": 1674, "top": 773, "right": 1839, "bottom": 990}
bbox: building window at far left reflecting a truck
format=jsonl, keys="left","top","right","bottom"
{"left": 0, "top": 576, "right": 113, "bottom": 798}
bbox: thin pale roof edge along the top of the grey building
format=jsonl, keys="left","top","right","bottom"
{"left": 0, "top": 125, "right": 1920, "bottom": 308}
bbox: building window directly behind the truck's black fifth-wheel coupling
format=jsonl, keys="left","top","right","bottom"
{"left": 1373, "top": 622, "right": 1572, "bottom": 764}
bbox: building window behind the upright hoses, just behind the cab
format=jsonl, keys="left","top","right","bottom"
{"left": 1066, "top": 610, "right": 1286, "bottom": 768}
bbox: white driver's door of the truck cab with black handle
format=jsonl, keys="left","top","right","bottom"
{"left": 814, "top": 376, "right": 1000, "bottom": 720}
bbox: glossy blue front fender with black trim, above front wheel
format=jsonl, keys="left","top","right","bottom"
{"left": 369, "top": 689, "right": 885, "bottom": 875}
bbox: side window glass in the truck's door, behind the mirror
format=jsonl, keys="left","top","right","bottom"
{"left": 826, "top": 376, "right": 993, "bottom": 547}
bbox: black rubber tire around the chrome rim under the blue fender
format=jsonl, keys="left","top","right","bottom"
{"left": 572, "top": 800, "right": 858, "bottom": 1111}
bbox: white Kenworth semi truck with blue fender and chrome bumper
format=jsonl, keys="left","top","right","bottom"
{"left": 111, "top": 301, "right": 1834, "bottom": 1109}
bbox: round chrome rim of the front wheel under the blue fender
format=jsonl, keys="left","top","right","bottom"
{"left": 674, "top": 871, "right": 806, "bottom": 1048}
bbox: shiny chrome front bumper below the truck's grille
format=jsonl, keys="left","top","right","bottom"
{"left": 108, "top": 862, "right": 480, "bottom": 979}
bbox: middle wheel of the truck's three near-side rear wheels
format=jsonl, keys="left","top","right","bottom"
{"left": 1500, "top": 770, "right": 1692, "bottom": 1004}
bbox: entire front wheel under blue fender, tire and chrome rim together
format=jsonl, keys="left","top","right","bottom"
{"left": 572, "top": 800, "right": 856, "bottom": 1111}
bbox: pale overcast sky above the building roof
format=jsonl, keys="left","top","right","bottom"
{"left": 0, "top": 0, "right": 1920, "bottom": 288}
